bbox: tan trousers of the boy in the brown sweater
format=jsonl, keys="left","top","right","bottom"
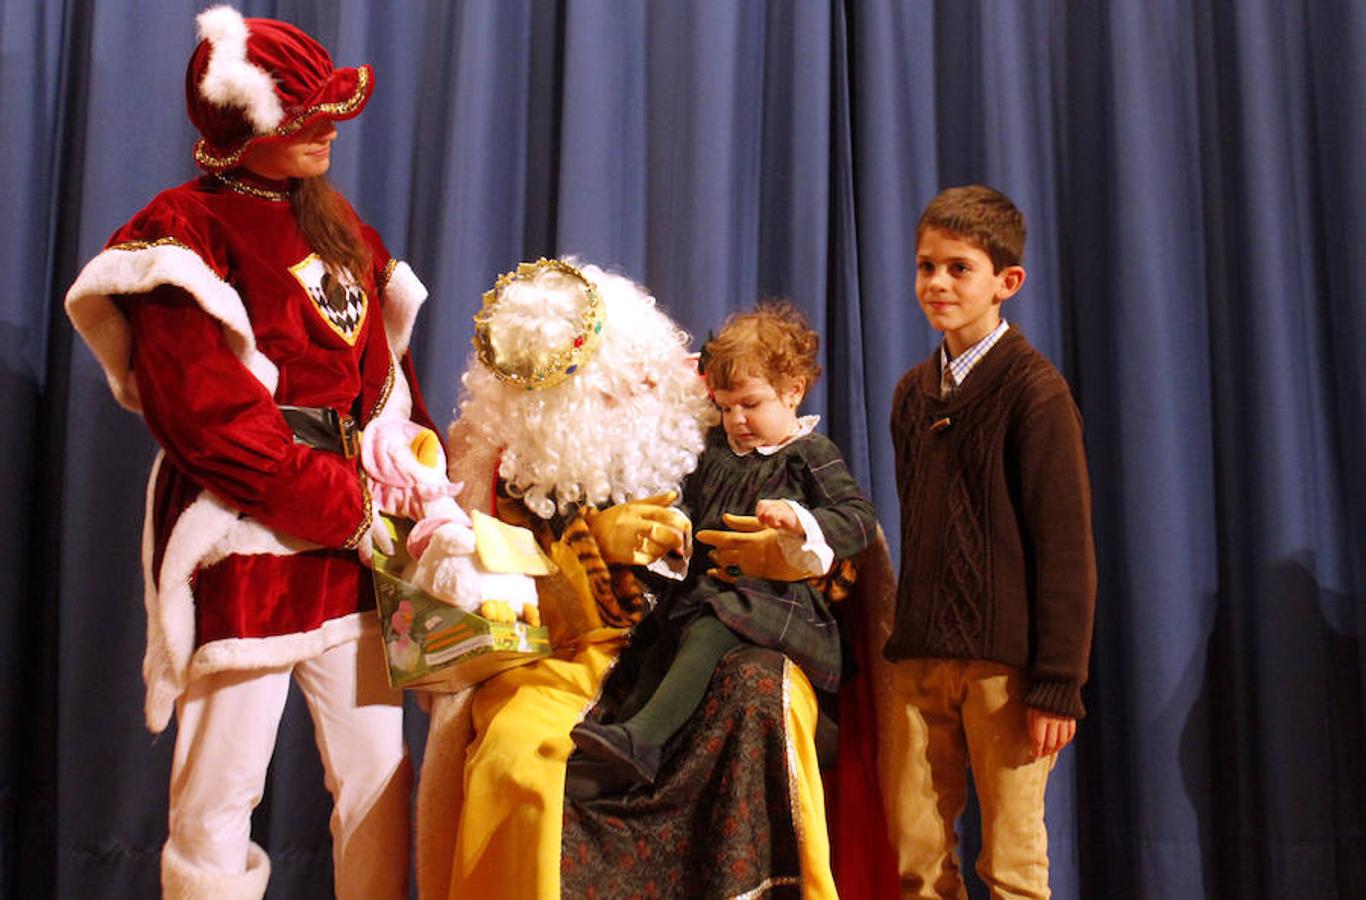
{"left": 878, "top": 660, "right": 1056, "bottom": 900}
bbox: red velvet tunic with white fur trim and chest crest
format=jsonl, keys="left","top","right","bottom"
{"left": 67, "top": 175, "right": 432, "bottom": 731}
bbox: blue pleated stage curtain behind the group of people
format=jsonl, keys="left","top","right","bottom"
{"left": 0, "top": 0, "right": 1366, "bottom": 900}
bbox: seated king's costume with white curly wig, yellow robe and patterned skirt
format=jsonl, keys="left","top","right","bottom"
{"left": 418, "top": 261, "right": 852, "bottom": 900}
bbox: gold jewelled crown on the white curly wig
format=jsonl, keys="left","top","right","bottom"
{"left": 474, "top": 257, "right": 607, "bottom": 391}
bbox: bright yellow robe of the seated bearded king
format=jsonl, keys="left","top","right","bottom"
{"left": 418, "top": 508, "right": 836, "bottom": 900}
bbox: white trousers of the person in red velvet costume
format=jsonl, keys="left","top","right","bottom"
{"left": 161, "top": 627, "right": 413, "bottom": 900}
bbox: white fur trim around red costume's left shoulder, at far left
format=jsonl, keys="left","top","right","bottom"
{"left": 66, "top": 243, "right": 280, "bottom": 412}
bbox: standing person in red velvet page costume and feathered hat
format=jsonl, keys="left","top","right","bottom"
{"left": 67, "top": 5, "right": 432, "bottom": 900}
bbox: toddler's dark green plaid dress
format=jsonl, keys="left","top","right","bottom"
{"left": 660, "top": 426, "right": 877, "bottom": 691}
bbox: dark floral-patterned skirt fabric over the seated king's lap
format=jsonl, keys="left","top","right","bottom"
{"left": 560, "top": 647, "right": 802, "bottom": 899}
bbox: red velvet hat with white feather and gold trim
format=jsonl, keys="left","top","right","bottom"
{"left": 184, "top": 5, "right": 374, "bottom": 172}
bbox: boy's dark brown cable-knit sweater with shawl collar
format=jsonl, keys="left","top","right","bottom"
{"left": 884, "top": 326, "right": 1096, "bottom": 718}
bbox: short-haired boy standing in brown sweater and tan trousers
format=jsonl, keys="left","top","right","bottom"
{"left": 878, "top": 184, "right": 1096, "bottom": 899}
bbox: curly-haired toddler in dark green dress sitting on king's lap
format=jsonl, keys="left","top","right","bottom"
{"left": 571, "top": 302, "right": 877, "bottom": 799}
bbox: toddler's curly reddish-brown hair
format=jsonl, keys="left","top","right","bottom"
{"left": 702, "top": 299, "right": 821, "bottom": 391}
